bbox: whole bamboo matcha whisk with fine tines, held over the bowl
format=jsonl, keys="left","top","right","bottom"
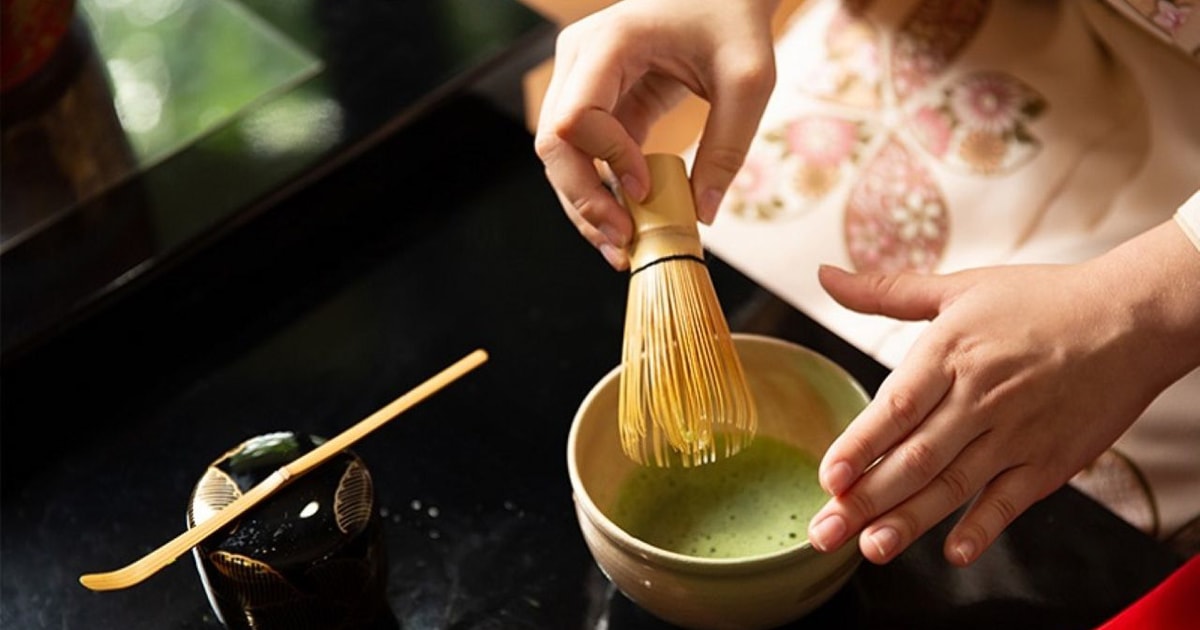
{"left": 618, "top": 154, "right": 757, "bottom": 467}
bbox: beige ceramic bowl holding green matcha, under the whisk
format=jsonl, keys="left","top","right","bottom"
{"left": 568, "top": 334, "right": 868, "bottom": 629}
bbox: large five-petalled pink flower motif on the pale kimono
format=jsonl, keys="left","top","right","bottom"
{"left": 728, "top": 0, "right": 1045, "bottom": 271}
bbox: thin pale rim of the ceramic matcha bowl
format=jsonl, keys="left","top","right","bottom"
{"left": 566, "top": 332, "right": 870, "bottom": 574}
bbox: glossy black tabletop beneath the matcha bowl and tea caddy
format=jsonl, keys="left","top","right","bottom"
{"left": 0, "top": 81, "right": 1182, "bottom": 630}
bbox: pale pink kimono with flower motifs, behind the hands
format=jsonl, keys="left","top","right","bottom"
{"left": 702, "top": 0, "right": 1200, "bottom": 553}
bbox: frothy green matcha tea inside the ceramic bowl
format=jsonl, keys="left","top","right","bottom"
{"left": 608, "top": 436, "right": 828, "bottom": 558}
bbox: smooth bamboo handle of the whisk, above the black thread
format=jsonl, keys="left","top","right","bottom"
{"left": 625, "top": 154, "right": 704, "bottom": 272}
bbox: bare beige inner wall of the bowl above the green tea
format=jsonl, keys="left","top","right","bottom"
{"left": 568, "top": 334, "right": 868, "bottom": 556}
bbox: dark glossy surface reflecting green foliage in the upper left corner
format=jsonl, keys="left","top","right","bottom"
{"left": 0, "top": 0, "right": 550, "bottom": 361}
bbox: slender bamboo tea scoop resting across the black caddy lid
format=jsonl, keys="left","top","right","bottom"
{"left": 79, "top": 349, "right": 487, "bottom": 590}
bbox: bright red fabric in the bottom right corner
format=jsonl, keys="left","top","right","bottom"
{"left": 1098, "top": 556, "right": 1200, "bottom": 630}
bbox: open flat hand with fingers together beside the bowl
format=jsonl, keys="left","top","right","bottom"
{"left": 809, "top": 218, "right": 1200, "bottom": 565}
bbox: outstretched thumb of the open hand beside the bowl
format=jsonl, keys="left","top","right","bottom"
{"left": 817, "top": 265, "right": 948, "bottom": 320}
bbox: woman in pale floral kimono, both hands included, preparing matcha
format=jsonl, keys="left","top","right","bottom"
{"left": 535, "top": 0, "right": 1200, "bottom": 565}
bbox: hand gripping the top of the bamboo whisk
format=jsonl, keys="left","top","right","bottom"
{"left": 535, "top": 0, "right": 779, "bottom": 270}
